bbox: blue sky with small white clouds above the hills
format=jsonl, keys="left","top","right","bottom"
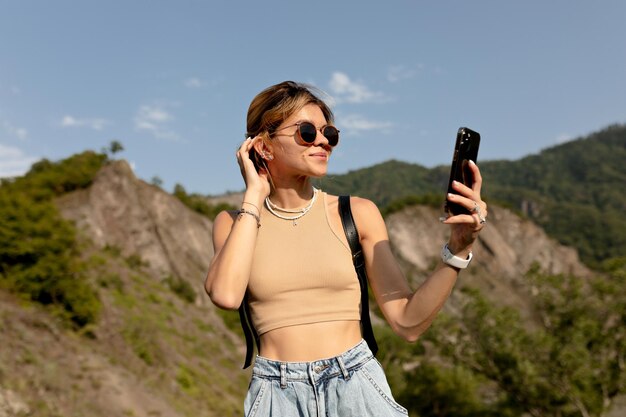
{"left": 0, "top": 0, "right": 626, "bottom": 195}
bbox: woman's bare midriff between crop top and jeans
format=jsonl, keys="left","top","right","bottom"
{"left": 259, "top": 320, "right": 362, "bottom": 362}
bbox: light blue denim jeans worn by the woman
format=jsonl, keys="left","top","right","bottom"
{"left": 244, "top": 340, "right": 408, "bottom": 417}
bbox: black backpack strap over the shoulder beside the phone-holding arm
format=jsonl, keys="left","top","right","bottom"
{"left": 339, "top": 195, "right": 378, "bottom": 355}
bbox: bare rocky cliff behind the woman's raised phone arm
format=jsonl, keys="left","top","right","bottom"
{"left": 386, "top": 206, "right": 590, "bottom": 317}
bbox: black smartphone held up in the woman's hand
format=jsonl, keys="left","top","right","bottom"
{"left": 445, "top": 127, "right": 480, "bottom": 216}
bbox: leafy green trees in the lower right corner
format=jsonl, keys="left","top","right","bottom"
{"left": 429, "top": 262, "right": 626, "bottom": 417}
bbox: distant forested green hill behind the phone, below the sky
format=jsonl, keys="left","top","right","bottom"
{"left": 320, "top": 125, "right": 626, "bottom": 266}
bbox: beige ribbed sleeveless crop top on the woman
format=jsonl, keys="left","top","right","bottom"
{"left": 248, "top": 191, "right": 361, "bottom": 334}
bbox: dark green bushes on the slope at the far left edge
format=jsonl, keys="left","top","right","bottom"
{"left": 0, "top": 191, "right": 100, "bottom": 326}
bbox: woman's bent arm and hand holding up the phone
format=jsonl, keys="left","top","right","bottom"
{"left": 353, "top": 164, "right": 487, "bottom": 341}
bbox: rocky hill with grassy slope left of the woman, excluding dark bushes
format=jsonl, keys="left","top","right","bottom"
{"left": 0, "top": 161, "right": 248, "bottom": 417}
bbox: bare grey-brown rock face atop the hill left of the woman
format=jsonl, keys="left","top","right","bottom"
{"left": 58, "top": 161, "right": 213, "bottom": 300}
